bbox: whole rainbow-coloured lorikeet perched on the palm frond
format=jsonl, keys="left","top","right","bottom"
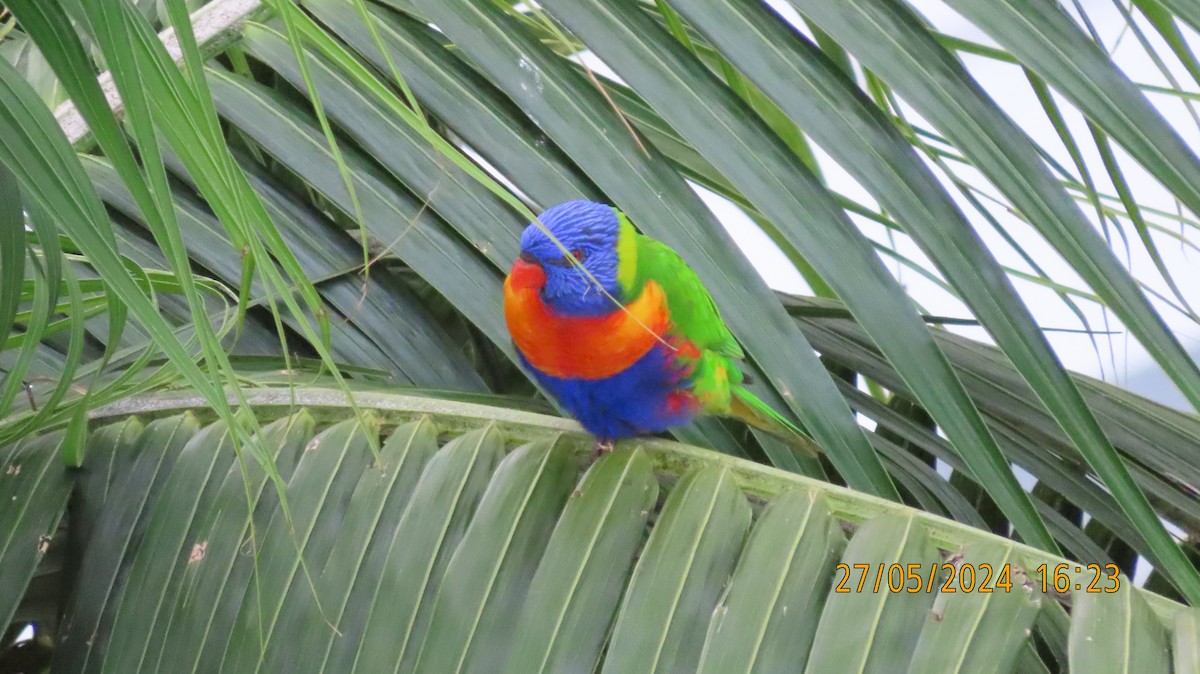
{"left": 504, "top": 200, "right": 811, "bottom": 453}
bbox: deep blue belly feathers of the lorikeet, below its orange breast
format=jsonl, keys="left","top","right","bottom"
{"left": 521, "top": 344, "right": 696, "bottom": 440}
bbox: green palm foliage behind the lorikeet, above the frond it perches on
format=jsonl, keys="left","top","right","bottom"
{"left": 0, "top": 0, "right": 1200, "bottom": 670}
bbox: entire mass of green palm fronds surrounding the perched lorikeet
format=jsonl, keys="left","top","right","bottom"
{"left": 0, "top": 0, "right": 1200, "bottom": 673}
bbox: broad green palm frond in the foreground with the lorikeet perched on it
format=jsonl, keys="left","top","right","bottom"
{"left": 0, "top": 387, "right": 1190, "bottom": 672}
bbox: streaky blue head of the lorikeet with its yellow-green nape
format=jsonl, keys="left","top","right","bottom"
{"left": 518, "top": 199, "right": 636, "bottom": 315}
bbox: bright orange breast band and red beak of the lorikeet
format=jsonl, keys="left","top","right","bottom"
{"left": 504, "top": 260, "right": 671, "bottom": 379}
